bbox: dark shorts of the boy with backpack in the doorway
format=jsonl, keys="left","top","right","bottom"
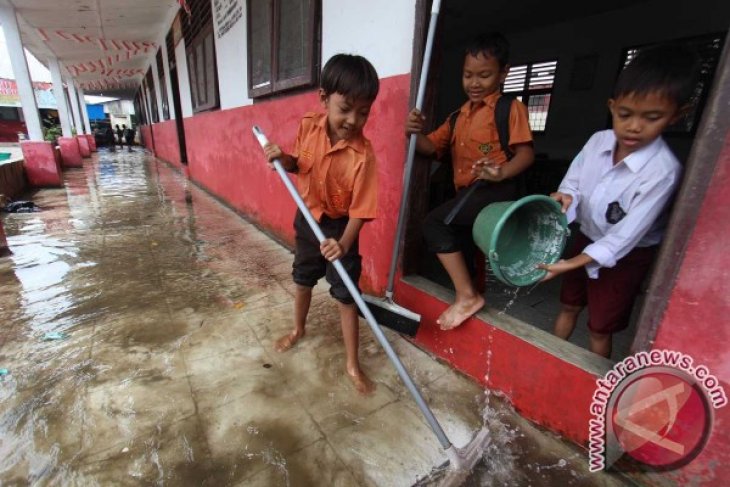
{"left": 423, "top": 179, "right": 517, "bottom": 254}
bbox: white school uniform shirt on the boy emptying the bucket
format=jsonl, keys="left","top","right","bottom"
{"left": 558, "top": 130, "right": 682, "bottom": 279}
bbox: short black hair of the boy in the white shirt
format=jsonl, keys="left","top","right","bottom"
{"left": 613, "top": 44, "right": 699, "bottom": 108}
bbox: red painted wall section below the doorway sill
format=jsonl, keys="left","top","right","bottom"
{"left": 395, "top": 282, "right": 596, "bottom": 444}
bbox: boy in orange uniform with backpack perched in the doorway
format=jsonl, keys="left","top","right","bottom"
{"left": 406, "top": 33, "right": 534, "bottom": 330}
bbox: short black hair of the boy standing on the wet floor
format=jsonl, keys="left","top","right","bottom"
{"left": 320, "top": 54, "right": 380, "bottom": 102}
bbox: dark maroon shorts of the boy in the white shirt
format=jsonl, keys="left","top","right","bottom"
{"left": 560, "top": 232, "right": 657, "bottom": 335}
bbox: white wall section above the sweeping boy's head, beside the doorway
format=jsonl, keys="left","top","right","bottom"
{"left": 322, "top": 0, "right": 416, "bottom": 78}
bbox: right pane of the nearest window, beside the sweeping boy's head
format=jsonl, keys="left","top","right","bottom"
{"left": 278, "top": 0, "right": 312, "bottom": 80}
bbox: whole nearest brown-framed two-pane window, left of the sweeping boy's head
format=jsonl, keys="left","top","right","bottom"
{"left": 246, "top": 0, "right": 321, "bottom": 98}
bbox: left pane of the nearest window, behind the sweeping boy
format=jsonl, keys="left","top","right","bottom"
{"left": 248, "top": 0, "right": 272, "bottom": 88}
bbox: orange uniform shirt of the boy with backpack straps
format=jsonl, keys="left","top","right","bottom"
{"left": 427, "top": 92, "right": 532, "bottom": 189}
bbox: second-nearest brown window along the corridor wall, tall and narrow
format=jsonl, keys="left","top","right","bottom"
{"left": 182, "top": 0, "right": 219, "bottom": 113}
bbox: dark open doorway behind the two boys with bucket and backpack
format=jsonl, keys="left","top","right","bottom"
{"left": 403, "top": 0, "right": 730, "bottom": 360}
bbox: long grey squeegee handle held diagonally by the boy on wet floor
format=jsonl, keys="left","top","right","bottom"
{"left": 253, "top": 125, "right": 451, "bottom": 450}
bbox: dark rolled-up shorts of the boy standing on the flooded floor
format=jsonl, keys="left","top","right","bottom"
{"left": 292, "top": 210, "right": 362, "bottom": 304}
